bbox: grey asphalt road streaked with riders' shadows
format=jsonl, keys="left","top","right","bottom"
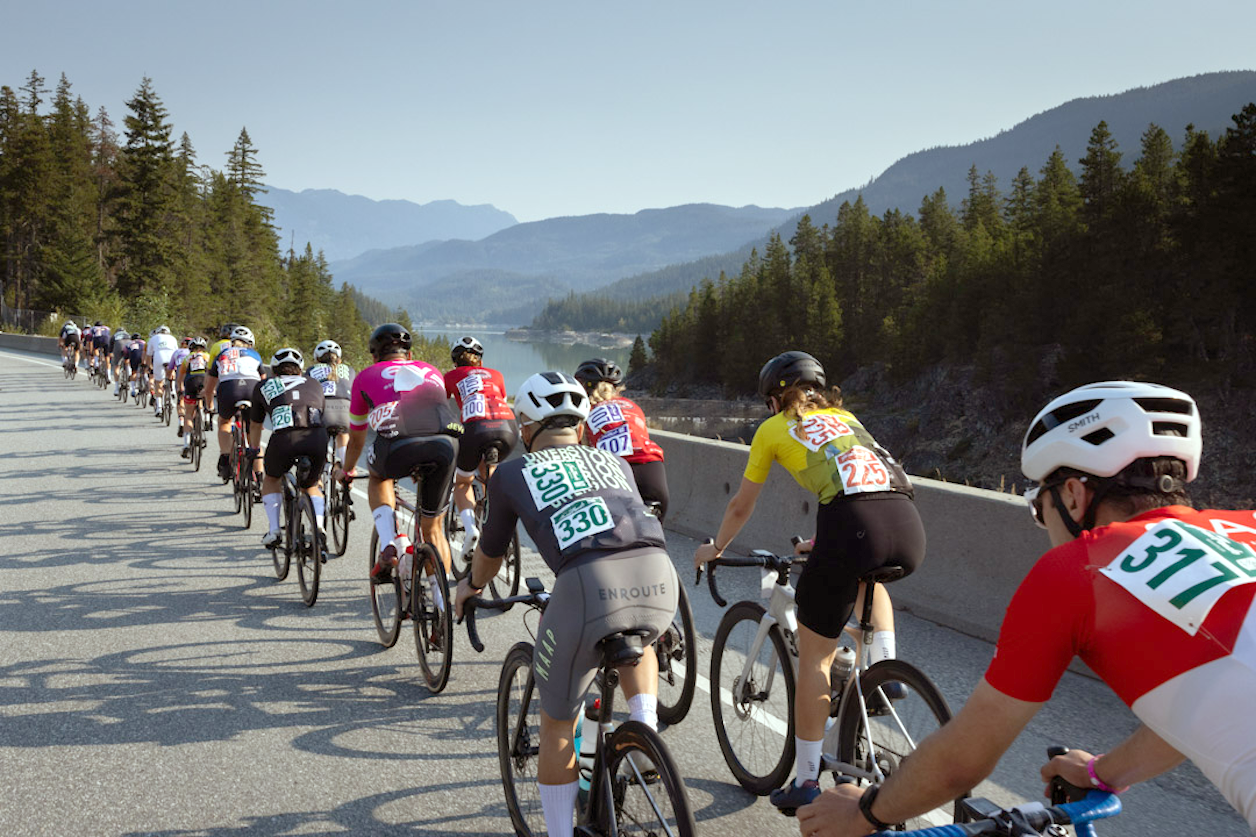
{"left": 0, "top": 352, "right": 1247, "bottom": 837}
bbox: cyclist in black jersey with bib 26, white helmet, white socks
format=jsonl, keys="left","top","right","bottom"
{"left": 249, "top": 348, "right": 327, "bottom": 549}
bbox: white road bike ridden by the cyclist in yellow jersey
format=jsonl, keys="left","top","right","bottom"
{"left": 698, "top": 549, "right": 967, "bottom": 828}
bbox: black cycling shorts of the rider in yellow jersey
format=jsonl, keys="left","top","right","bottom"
{"left": 794, "top": 491, "right": 924, "bottom": 640}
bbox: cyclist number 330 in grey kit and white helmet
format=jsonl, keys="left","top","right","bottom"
{"left": 456, "top": 372, "right": 679, "bottom": 837}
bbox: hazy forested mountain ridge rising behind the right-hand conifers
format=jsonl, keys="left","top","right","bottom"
{"left": 567, "top": 70, "right": 1256, "bottom": 316}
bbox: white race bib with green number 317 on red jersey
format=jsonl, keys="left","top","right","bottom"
{"left": 1099, "top": 520, "right": 1256, "bottom": 636}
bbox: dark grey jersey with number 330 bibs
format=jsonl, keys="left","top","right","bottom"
{"left": 480, "top": 445, "right": 667, "bottom": 574}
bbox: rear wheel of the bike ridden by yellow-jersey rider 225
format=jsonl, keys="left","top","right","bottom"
{"left": 838, "top": 660, "right": 967, "bottom": 829}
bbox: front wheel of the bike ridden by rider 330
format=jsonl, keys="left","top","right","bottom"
{"left": 497, "top": 642, "right": 545, "bottom": 837}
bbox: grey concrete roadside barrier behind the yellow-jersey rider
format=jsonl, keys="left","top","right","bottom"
{"left": 651, "top": 430, "right": 1050, "bottom": 641}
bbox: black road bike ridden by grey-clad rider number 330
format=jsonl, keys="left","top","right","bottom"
{"left": 463, "top": 578, "right": 697, "bottom": 837}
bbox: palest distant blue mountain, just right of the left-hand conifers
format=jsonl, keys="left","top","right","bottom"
{"left": 260, "top": 186, "right": 517, "bottom": 261}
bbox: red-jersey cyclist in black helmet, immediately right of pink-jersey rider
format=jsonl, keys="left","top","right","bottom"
{"left": 445, "top": 337, "right": 519, "bottom": 559}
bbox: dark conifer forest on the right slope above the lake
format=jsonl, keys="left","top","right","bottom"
{"left": 649, "top": 103, "right": 1256, "bottom": 401}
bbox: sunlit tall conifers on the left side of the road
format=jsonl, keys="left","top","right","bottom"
{"left": 0, "top": 73, "right": 396, "bottom": 368}
